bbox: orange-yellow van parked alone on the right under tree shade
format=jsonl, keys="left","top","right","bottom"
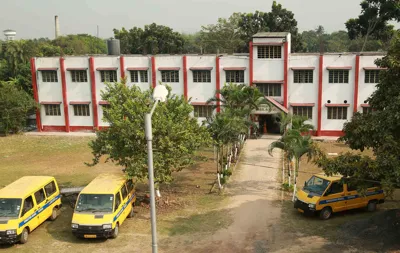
{"left": 294, "top": 174, "right": 385, "bottom": 220}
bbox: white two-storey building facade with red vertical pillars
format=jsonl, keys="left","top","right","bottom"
{"left": 31, "top": 33, "right": 384, "bottom": 136}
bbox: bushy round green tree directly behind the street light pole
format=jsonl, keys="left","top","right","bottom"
{"left": 90, "top": 83, "right": 210, "bottom": 193}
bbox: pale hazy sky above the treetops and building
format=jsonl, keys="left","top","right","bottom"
{"left": 0, "top": 0, "right": 388, "bottom": 39}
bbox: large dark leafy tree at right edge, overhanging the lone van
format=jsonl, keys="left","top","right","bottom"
{"left": 317, "top": 34, "right": 400, "bottom": 190}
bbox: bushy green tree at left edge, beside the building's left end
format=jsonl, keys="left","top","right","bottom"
{"left": 0, "top": 81, "right": 36, "bottom": 135}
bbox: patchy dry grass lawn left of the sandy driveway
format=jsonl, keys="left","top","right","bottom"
{"left": 0, "top": 135, "right": 231, "bottom": 252}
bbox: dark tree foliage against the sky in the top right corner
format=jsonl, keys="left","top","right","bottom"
{"left": 345, "top": 0, "right": 400, "bottom": 51}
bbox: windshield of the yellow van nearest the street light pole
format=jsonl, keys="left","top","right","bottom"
{"left": 75, "top": 194, "right": 114, "bottom": 213}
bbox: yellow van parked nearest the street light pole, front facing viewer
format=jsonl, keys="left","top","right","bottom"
{"left": 71, "top": 174, "right": 136, "bottom": 238}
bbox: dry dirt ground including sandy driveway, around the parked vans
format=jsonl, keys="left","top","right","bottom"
{"left": 0, "top": 136, "right": 400, "bottom": 253}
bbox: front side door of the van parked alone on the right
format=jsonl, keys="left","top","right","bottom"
{"left": 319, "top": 181, "right": 346, "bottom": 212}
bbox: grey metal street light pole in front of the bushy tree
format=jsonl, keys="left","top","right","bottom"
{"left": 144, "top": 100, "right": 158, "bottom": 253}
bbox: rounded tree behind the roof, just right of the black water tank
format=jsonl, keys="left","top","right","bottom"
{"left": 114, "top": 23, "right": 185, "bottom": 54}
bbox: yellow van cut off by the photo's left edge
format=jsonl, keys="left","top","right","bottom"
{"left": 0, "top": 176, "right": 61, "bottom": 243}
